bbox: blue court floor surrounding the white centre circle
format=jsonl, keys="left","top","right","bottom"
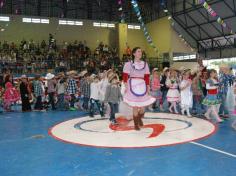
{"left": 0, "top": 111, "right": 236, "bottom": 176}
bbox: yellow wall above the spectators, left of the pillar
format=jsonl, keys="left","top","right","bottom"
{"left": 0, "top": 16, "right": 117, "bottom": 49}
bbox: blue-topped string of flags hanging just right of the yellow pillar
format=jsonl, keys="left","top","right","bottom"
{"left": 131, "top": 0, "right": 158, "bottom": 53}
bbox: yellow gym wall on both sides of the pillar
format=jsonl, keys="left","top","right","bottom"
{"left": 0, "top": 16, "right": 194, "bottom": 57}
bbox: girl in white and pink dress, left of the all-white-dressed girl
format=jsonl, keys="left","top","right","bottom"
{"left": 166, "top": 70, "right": 180, "bottom": 114}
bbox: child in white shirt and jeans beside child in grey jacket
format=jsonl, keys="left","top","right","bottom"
{"left": 89, "top": 76, "right": 104, "bottom": 117}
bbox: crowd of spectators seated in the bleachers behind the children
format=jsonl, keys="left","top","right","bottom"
{"left": 0, "top": 34, "right": 121, "bottom": 74}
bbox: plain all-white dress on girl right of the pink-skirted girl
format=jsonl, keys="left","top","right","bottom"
{"left": 179, "top": 80, "right": 193, "bottom": 109}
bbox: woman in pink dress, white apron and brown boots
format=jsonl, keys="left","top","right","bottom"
{"left": 123, "top": 47, "right": 155, "bottom": 130}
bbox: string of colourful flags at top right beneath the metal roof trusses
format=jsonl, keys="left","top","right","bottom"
{"left": 195, "top": 0, "right": 235, "bottom": 35}
